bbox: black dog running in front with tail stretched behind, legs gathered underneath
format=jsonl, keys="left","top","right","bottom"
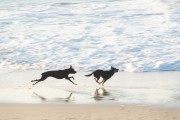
{"left": 85, "top": 67, "right": 119, "bottom": 85}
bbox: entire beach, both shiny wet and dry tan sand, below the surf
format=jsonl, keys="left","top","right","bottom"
{"left": 0, "top": 71, "right": 180, "bottom": 120}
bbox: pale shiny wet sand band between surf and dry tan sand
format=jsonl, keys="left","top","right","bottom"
{"left": 0, "top": 70, "right": 180, "bottom": 108}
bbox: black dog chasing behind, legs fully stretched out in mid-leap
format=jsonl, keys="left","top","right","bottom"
{"left": 31, "top": 66, "right": 77, "bottom": 85}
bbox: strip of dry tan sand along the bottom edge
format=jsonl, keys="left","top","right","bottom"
{"left": 0, "top": 104, "right": 180, "bottom": 120}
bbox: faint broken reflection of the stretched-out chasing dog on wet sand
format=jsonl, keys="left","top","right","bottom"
{"left": 33, "top": 92, "right": 73, "bottom": 103}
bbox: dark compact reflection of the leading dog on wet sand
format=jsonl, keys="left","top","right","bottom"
{"left": 93, "top": 88, "right": 115, "bottom": 101}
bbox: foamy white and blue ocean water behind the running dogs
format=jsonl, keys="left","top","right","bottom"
{"left": 0, "top": 0, "right": 180, "bottom": 72}
